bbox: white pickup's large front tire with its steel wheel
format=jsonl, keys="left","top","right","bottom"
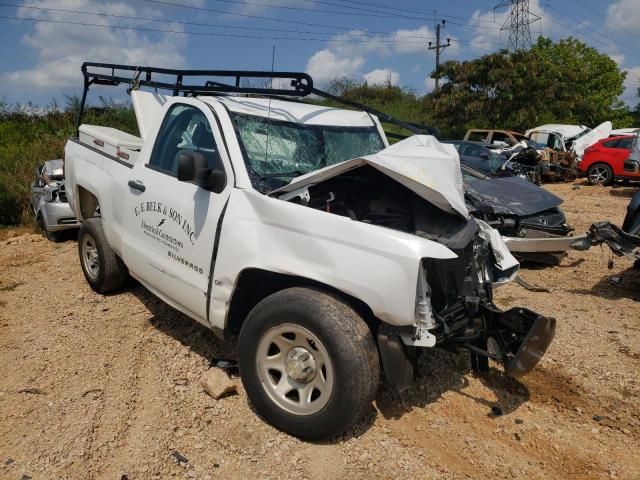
{"left": 238, "top": 288, "right": 380, "bottom": 440}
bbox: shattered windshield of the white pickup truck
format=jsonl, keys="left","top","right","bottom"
{"left": 232, "top": 113, "right": 384, "bottom": 179}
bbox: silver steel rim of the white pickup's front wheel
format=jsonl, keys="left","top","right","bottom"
{"left": 256, "top": 323, "right": 334, "bottom": 415}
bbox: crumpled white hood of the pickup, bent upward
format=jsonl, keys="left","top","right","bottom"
{"left": 271, "top": 135, "right": 469, "bottom": 218}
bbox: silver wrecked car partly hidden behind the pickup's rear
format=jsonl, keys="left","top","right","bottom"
{"left": 29, "top": 159, "right": 80, "bottom": 242}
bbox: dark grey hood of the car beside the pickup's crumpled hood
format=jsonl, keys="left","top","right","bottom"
{"left": 465, "top": 177, "right": 562, "bottom": 216}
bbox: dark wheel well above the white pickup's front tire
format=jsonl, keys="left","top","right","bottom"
{"left": 225, "top": 268, "right": 379, "bottom": 335}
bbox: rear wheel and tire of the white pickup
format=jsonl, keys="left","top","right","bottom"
{"left": 78, "top": 218, "right": 127, "bottom": 293}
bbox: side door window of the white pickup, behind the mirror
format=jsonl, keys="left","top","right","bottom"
{"left": 149, "top": 104, "right": 223, "bottom": 177}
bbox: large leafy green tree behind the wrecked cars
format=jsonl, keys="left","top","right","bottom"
{"left": 424, "top": 37, "right": 632, "bottom": 137}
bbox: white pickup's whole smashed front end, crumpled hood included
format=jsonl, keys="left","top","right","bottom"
{"left": 271, "top": 139, "right": 555, "bottom": 390}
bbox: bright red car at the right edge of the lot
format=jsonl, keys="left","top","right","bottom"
{"left": 578, "top": 135, "right": 640, "bottom": 185}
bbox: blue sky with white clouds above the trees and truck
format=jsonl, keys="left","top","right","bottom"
{"left": 0, "top": 0, "right": 640, "bottom": 106}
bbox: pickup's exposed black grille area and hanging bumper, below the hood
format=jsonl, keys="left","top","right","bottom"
{"left": 378, "top": 228, "right": 555, "bottom": 391}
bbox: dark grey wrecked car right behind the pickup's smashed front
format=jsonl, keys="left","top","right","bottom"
{"left": 462, "top": 165, "right": 576, "bottom": 265}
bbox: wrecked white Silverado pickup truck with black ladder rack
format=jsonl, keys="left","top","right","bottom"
{"left": 65, "top": 64, "right": 555, "bottom": 439}
